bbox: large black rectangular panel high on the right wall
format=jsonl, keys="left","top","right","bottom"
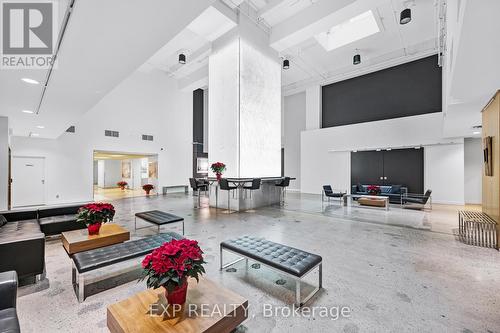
{"left": 322, "top": 56, "right": 442, "bottom": 128}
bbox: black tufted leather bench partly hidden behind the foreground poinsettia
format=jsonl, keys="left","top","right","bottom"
{"left": 71, "top": 232, "right": 183, "bottom": 302}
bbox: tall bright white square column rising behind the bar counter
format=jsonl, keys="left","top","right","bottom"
{"left": 208, "top": 16, "right": 281, "bottom": 177}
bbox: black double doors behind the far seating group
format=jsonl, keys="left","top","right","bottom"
{"left": 351, "top": 148, "right": 424, "bottom": 194}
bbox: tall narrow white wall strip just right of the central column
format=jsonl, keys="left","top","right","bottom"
{"left": 283, "top": 92, "right": 306, "bottom": 189}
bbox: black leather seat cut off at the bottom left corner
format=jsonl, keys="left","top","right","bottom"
{"left": 0, "top": 271, "right": 21, "bottom": 333}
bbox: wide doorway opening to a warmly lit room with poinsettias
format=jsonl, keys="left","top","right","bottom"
{"left": 92, "top": 151, "right": 158, "bottom": 201}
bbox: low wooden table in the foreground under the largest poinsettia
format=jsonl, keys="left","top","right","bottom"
{"left": 107, "top": 277, "right": 248, "bottom": 333}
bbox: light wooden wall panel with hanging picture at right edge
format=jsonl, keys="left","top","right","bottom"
{"left": 482, "top": 91, "right": 500, "bottom": 241}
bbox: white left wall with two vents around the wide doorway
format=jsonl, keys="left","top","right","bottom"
{"left": 11, "top": 71, "right": 193, "bottom": 204}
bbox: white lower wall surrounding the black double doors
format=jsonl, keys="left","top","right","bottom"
{"left": 300, "top": 113, "right": 464, "bottom": 203}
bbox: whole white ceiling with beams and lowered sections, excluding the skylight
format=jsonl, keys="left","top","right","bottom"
{"left": 0, "top": 0, "right": 494, "bottom": 138}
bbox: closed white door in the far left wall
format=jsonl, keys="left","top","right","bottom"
{"left": 12, "top": 156, "right": 45, "bottom": 207}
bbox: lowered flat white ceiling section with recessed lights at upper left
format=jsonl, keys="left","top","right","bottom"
{"left": 0, "top": 0, "right": 214, "bottom": 138}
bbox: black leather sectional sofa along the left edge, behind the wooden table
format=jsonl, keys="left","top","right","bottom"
{"left": 0, "top": 205, "right": 85, "bottom": 283}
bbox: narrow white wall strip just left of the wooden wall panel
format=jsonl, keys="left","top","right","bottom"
{"left": 464, "top": 138, "right": 483, "bottom": 204}
